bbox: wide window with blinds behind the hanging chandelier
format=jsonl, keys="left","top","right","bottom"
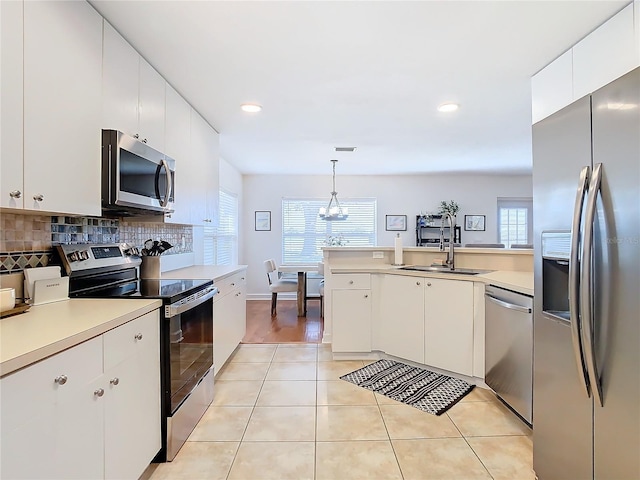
{"left": 282, "top": 198, "right": 376, "bottom": 263}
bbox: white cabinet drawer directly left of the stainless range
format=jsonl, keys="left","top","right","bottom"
{"left": 103, "top": 310, "right": 160, "bottom": 371}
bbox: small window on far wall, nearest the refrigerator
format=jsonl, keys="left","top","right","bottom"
{"left": 498, "top": 198, "right": 533, "bottom": 248}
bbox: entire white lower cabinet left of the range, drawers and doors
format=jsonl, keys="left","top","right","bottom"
{"left": 0, "top": 311, "right": 160, "bottom": 480}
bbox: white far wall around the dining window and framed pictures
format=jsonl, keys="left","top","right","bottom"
{"left": 240, "top": 175, "right": 532, "bottom": 298}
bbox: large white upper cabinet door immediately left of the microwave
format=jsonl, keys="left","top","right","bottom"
{"left": 24, "top": 2, "right": 102, "bottom": 215}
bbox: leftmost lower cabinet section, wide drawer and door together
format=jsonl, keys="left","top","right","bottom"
{"left": 0, "top": 337, "right": 103, "bottom": 479}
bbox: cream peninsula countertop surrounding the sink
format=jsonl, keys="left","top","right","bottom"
{"left": 331, "top": 264, "right": 533, "bottom": 296}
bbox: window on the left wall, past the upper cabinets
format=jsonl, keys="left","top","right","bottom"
{"left": 204, "top": 190, "right": 238, "bottom": 265}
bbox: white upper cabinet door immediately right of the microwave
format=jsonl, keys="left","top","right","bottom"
{"left": 165, "top": 84, "right": 191, "bottom": 224}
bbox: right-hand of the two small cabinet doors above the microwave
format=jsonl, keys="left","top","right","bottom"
{"left": 138, "top": 57, "right": 165, "bottom": 152}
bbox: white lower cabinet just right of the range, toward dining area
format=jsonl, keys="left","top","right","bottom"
{"left": 213, "top": 271, "right": 247, "bottom": 374}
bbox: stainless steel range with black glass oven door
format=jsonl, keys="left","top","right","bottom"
{"left": 56, "top": 244, "right": 218, "bottom": 462}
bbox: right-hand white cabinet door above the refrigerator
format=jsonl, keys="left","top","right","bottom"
{"left": 573, "top": 5, "right": 640, "bottom": 100}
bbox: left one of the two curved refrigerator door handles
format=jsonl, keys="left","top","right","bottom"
{"left": 569, "top": 167, "right": 591, "bottom": 397}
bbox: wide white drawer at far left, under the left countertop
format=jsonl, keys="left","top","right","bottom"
{"left": 0, "top": 337, "right": 102, "bottom": 431}
